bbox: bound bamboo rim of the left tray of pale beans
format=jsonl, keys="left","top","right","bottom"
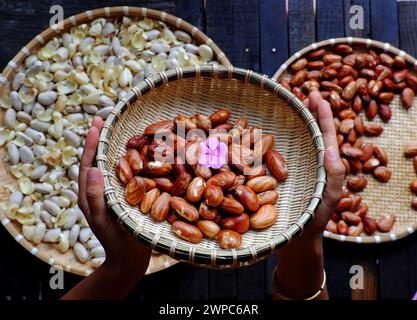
{"left": 0, "top": 6, "right": 231, "bottom": 276}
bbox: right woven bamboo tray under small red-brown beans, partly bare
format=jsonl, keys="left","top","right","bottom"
{"left": 273, "top": 37, "right": 417, "bottom": 243}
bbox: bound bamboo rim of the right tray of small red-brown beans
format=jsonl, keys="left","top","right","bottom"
{"left": 273, "top": 37, "right": 417, "bottom": 244}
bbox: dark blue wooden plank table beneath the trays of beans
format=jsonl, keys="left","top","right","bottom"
{"left": 0, "top": 0, "right": 417, "bottom": 300}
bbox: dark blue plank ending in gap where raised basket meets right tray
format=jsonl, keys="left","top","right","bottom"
{"left": 259, "top": 0, "right": 288, "bottom": 76}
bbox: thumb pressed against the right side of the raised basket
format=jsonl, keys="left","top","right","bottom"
{"left": 322, "top": 146, "right": 346, "bottom": 214}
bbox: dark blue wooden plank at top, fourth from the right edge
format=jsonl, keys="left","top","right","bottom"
{"left": 316, "top": 0, "right": 345, "bottom": 41}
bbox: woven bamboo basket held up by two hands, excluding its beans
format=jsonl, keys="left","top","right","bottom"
{"left": 97, "top": 65, "right": 326, "bottom": 268}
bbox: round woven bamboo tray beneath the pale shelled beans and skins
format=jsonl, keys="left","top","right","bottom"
{"left": 0, "top": 6, "right": 230, "bottom": 276}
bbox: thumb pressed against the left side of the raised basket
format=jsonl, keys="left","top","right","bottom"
{"left": 86, "top": 168, "right": 108, "bottom": 225}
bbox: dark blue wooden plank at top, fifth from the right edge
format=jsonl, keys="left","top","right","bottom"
{"left": 288, "top": 0, "right": 316, "bottom": 55}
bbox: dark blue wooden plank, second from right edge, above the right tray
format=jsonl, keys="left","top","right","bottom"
{"left": 370, "top": 0, "right": 399, "bottom": 47}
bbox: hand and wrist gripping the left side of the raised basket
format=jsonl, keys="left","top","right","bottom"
{"left": 78, "top": 117, "right": 151, "bottom": 279}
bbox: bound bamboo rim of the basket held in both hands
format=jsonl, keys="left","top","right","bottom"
{"left": 96, "top": 65, "right": 326, "bottom": 268}
